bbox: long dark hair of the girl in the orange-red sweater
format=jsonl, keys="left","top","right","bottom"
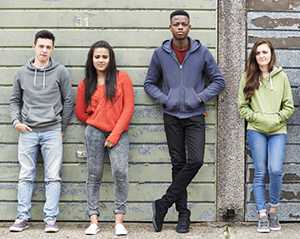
{"left": 84, "top": 41, "right": 118, "bottom": 104}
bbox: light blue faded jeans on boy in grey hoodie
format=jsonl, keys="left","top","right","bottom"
{"left": 17, "top": 128, "right": 63, "bottom": 222}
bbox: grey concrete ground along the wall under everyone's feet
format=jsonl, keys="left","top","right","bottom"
{"left": 0, "top": 222, "right": 300, "bottom": 239}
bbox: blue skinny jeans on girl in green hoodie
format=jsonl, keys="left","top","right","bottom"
{"left": 247, "top": 130, "right": 287, "bottom": 212}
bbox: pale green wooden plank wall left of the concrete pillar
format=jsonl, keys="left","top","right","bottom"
{"left": 0, "top": 0, "right": 217, "bottom": 221}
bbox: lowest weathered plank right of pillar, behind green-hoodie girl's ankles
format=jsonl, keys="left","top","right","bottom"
{"left": 245, "top": 203, "right": 300, "bottom": 221}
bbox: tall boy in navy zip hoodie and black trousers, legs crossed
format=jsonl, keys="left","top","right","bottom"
{"left": 144, "top": 10, "right": 225, "bottom": 233}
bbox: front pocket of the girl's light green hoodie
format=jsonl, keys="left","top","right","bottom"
{"left": 251, "top": 112, "right": 283, "bottom": 133}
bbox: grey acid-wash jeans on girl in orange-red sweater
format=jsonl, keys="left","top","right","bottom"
{"left": 85, "top": 126, "right": 129, "bottom": 216}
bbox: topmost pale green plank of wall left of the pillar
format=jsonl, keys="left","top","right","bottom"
{"left": 0, "top": 0, "right": 217, "bottom": 10}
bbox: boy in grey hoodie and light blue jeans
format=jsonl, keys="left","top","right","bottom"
{"left": 9, "top": 30, "right": 73, "bottom": 232}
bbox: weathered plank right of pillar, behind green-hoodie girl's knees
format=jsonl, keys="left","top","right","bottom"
{"left": 247, "top": 163, "right": 300, "bottom": 183}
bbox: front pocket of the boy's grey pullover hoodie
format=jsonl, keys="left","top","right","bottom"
{"left": 26, "top": 105, "right": 56, "bottom": 124}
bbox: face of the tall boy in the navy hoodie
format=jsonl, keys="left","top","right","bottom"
{"left": 169, "top": 15, "right": 191, "bottom": 40}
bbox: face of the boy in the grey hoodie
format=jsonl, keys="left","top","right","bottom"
{"left": 33, "top": 38, "right": 54, "bottom": 64}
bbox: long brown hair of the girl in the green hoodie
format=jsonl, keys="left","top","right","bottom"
{"left": 244, "top": 39, "right": 276, "bottom": 100}
